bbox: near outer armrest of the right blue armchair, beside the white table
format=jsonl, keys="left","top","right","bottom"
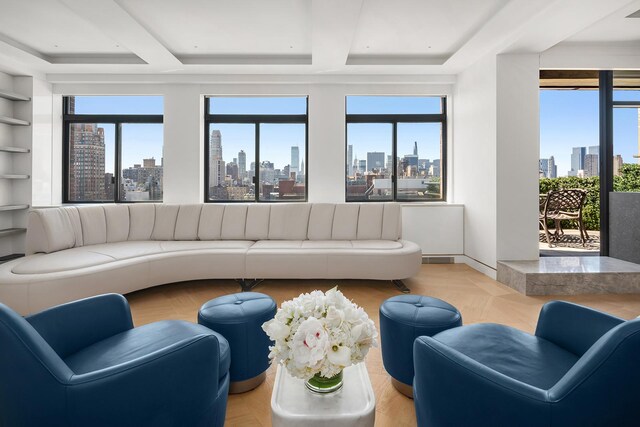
{"left": 413, "top": 337, "right": 551, "bottom": 426}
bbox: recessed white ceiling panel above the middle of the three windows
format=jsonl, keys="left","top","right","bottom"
{"left": 117, "top": 0, "right": 311, "bottom": 56}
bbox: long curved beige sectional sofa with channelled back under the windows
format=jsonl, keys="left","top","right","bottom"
{"left": 0, "top": 203, "right": 422, "bottom": 314}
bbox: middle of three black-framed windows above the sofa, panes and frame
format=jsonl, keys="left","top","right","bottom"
{"left": 205, "top": 96, "right": 307, "bottom": 202}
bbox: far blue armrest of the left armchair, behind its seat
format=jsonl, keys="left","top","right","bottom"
{"left": 26, "top": 294, "right": 133, "bottom": 359}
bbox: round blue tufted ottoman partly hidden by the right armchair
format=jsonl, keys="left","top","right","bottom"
{"left": 380, "top": 295, "right": 462, "bottom": 398}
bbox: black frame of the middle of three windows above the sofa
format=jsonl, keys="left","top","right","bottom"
{"left": 204, "top": 95, "right": 309, "bottom": 203}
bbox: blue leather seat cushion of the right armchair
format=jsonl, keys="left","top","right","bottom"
{"left": 433, "top": 323, "right": 578, "bottom": 390}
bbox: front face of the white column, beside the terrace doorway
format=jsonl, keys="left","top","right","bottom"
{"left": 496, "top": 54, "right": 540, "bottom": 261}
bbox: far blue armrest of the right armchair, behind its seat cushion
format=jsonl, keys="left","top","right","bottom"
{"left": 536, "top": 301, "right": 624, "bottom": 356}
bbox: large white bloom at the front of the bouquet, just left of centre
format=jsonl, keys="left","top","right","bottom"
{"left": 293, "top": 317, "right": 329, "bottom": 367}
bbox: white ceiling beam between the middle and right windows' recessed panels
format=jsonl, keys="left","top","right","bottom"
{"left": 311, "top": 0, "right": 363, "bottom": 72}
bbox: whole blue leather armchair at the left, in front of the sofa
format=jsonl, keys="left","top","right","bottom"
{"left": 0, "top": 294, "right": 230, "bottom": 426}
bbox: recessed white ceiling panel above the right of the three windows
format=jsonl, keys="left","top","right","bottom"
{"left": 350, "top": 0, "right": 506, "bottom": 56}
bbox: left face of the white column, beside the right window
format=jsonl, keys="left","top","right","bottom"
{"left": 452, "top": 56, "right": 497, "bottom": 269}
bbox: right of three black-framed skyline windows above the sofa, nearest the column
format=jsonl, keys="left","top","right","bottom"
{"left": 345, "top": 96, "right": 447, "bottom": 202}
